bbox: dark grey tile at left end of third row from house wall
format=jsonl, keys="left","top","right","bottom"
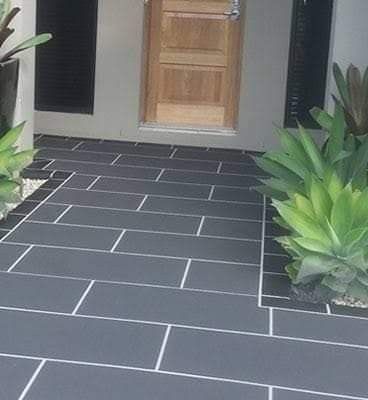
{"left": 38, "top": 149, "right": 118, "bottom": 164}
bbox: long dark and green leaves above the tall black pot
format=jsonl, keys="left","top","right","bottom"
{"left": 0, "top": 0, "right": 52, "bottom": 62}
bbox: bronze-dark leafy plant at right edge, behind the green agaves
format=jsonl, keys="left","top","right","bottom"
{"left": 333, "top": 63, "right": 368, "bottom": 136}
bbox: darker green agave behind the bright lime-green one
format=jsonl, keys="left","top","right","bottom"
{"left": 255, "top": 104, "right": 368, "bottom": 200}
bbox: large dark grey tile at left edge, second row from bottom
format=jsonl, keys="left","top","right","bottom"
{"left": 0, "top": 310, "right": 165, "bottom": 368}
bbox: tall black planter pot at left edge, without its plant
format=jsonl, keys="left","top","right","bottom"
{"left": 0, "top": 58, "right": 19, "bottom": 137}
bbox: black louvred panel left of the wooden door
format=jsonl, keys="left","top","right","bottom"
{"left": 35, "top": 0, "right": 98, "bottom": 114}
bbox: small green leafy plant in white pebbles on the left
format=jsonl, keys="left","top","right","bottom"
{"left": 0, "top": 122, "right": 37, "bottom": 218}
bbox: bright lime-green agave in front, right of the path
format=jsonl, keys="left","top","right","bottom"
{"left": 273, "top": 178, "right": 368, "bottom": 301}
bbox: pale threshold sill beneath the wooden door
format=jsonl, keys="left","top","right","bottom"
{"left": 139, "top": 122, "right": 238, "bottom": 136}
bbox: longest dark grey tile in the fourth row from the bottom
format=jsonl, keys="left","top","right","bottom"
{"left": 14, "top": 247, "right": 186, "bottom": 286}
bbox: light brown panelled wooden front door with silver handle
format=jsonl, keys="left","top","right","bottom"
{"left": 144, "top": 0, "right": 244, "bottom": 128}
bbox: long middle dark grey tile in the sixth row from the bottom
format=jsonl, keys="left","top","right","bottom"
{"left": 60, "top": 207, "right": 201, "bottom": 234}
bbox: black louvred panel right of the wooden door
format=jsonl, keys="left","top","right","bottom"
{"left": 285, "top": 0, "right": 333, "bottom": 128}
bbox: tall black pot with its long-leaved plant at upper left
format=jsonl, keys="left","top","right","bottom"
{"left": 0, "top": 0, "right": 52, "bottom": 137}
